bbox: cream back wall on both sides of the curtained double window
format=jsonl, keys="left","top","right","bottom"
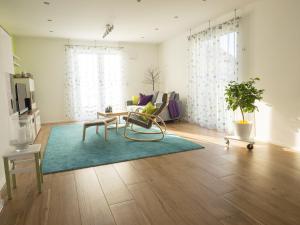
{"left": 15, "top": 37, "right": 158, "bottom": 123}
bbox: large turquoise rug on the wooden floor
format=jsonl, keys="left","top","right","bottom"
{"left": 43, "top": 124, "right": 203, "bottom": 174}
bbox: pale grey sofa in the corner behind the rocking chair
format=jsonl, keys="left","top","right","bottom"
{"left": 126, "top": 91, "right": 182, "bottom": 122}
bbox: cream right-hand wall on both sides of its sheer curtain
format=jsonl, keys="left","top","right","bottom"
{"left": 159, "top": 0, "right": 300, "bottom": 149}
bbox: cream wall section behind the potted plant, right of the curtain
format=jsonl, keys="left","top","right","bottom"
{"left": 245, "top": 0, "right": 300, "bottom": 149}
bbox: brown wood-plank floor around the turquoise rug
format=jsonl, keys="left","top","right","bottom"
{"left": 0, "top": 123, "right": 300, "bottom": 225}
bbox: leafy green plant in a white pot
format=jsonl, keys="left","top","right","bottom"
{"left": 225, "top": 78, "right": 265, "bottom": 140}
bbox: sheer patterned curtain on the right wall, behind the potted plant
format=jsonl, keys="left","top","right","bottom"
{"left": 188, "top": 19, "right": 239, "bottom": 132}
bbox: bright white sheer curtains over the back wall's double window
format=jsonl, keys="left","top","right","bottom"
{"left": 65, "top": 46, "right": 124, "bottom": 120}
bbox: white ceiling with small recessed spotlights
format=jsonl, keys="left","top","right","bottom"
{"left": 0, "top": 0, "right": 254, "bottom": 43}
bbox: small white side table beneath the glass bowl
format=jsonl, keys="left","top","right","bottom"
{"left": 3, "top": 144, "right": 43, "bottom": 199}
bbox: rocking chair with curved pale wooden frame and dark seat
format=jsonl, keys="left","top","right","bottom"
{"left": 123, "top": 93, "right": 168, "bottom": 142}
